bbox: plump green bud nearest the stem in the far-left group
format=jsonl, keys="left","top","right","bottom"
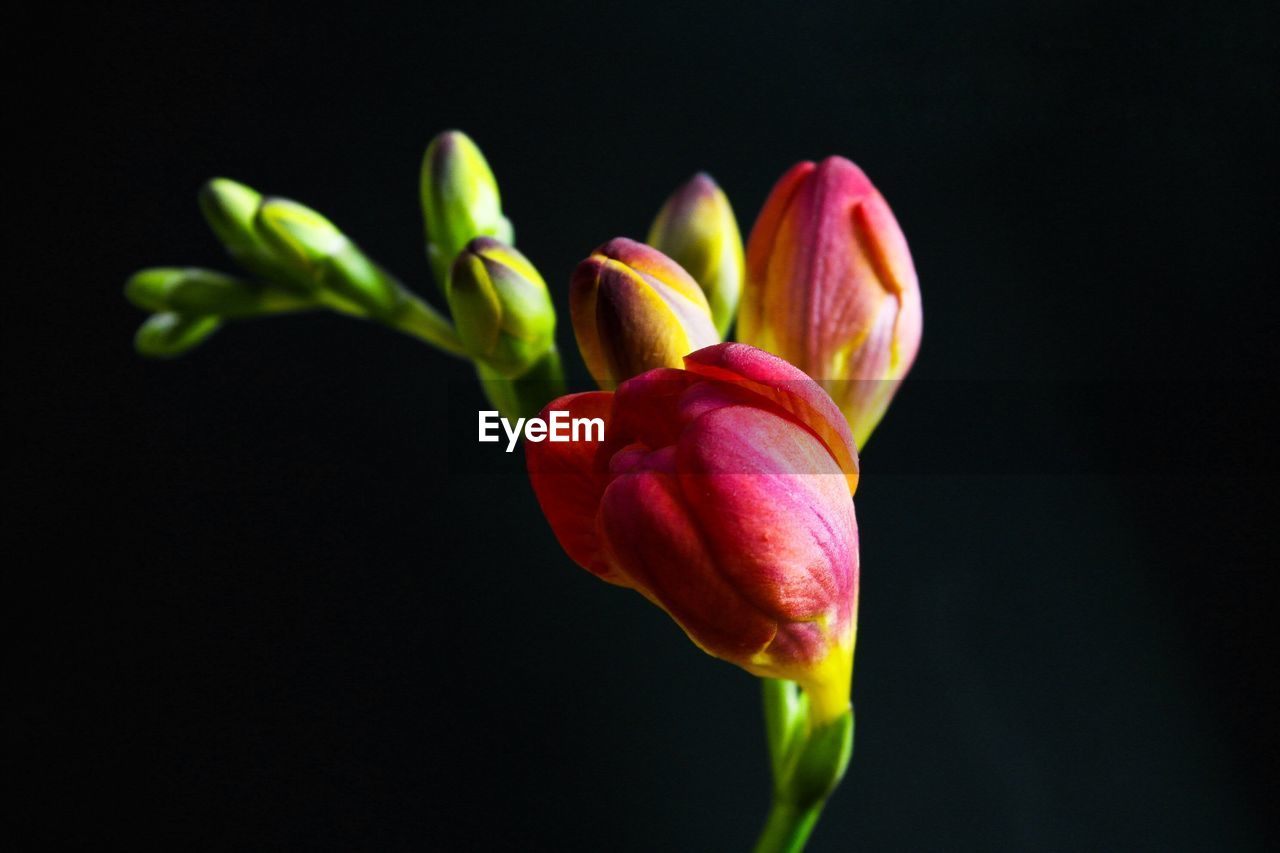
{"left": 255, "top": 199, "right": 401, "bottom": 316}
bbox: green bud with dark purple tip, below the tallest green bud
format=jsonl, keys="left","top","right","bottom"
{"left": 445, "top": 237, "right": 556, "bottom": 377}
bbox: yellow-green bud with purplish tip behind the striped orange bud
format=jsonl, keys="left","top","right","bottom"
{"left": 646, "top": 172, "right": 745, "bottom": 337}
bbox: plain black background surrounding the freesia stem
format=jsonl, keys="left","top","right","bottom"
{"left": 12, "top": 3, "right": 1280, "bottom": 850}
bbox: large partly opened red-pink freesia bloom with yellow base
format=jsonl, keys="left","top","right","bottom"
{"left": 526, "top": 343, "right": 858, "bottom": 722}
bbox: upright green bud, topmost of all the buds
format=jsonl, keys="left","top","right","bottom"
{"left": 421, "top": 131, "right": 515, "bottom": 287}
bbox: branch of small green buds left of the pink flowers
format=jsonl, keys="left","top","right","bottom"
{"left": 125, "top": 131, "right": 563, "bottom": 414}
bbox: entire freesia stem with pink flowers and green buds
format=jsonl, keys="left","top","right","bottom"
{"left": 125, "top": 131, "right": 922, "bottom": 850}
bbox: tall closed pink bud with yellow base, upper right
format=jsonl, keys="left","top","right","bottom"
{"left": 737, "top": 158, "right": 922, "bottom": 447}
